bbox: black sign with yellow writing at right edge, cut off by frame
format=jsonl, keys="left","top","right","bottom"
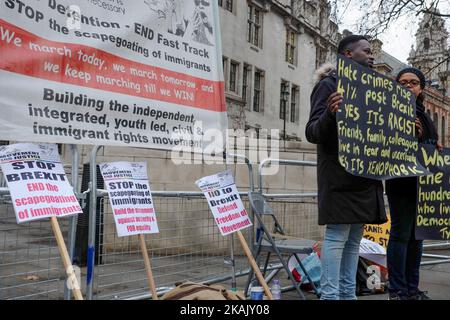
{"left": 416, "top": 144, "right": 450, "bottom": 241}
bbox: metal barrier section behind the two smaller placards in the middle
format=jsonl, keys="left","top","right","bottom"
{"left": 93, "top": 192, "right": 253, "bottom": 299}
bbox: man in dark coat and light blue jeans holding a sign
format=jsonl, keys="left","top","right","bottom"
{"left": 306, "top": 35, "right": 387, "bottom": 300}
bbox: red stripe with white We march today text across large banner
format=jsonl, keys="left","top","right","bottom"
{"left": 0, "top": 19, "right": 226, "bottom": 112}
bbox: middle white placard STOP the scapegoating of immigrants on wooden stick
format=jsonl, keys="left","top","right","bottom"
{"left": 99, "top": 161, "right": 159, "bottom": 300}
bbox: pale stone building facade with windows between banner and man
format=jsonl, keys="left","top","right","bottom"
{"left": 219, "top": 0, "right": 340, "bottom": 142}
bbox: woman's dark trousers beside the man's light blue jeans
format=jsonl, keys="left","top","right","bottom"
{"left": 387, "top": 191, "right": 423, "bottom": 297}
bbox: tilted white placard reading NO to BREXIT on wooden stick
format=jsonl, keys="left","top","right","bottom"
{"left": 195, "top": 170, "right": 273, "bottom": 300}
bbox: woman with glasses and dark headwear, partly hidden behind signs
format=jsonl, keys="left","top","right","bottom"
{"left": 386, "top": 68, "right": 442, "bottom": 300}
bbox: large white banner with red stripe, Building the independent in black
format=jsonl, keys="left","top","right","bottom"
{"left": 0, "top": 0, "right": 227, "bottom": 152}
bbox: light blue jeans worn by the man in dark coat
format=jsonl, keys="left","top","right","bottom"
{"left": 320, "top": 224, "right": 364, "bottom": 300}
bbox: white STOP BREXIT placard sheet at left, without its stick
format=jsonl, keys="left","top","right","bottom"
{"left": 0, "top": 143, "right": 83, "bottom": 223}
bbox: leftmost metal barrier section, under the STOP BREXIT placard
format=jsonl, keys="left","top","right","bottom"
{"left": 0, "top": 188, "right": 69, "bottom": 300}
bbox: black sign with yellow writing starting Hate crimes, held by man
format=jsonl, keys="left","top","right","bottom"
{"left": 337, "top": 55, "right": 427, "bottom": 180}
